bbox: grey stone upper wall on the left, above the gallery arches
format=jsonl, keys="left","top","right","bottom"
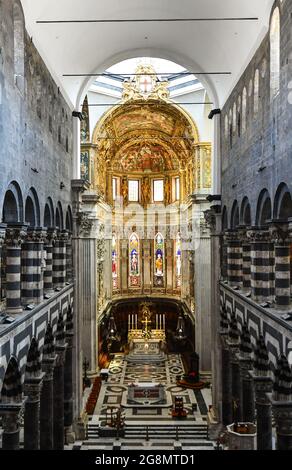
{"left": 0, "top": 0, "right": 73, "bottom": 218}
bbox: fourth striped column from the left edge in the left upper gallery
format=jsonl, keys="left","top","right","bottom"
{"left": 53, "top": 230, "right": 68, "bottom": 288}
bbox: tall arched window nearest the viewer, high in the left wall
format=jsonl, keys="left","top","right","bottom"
{"left": 13, "top": 1, "right": 24, "bottom": 92}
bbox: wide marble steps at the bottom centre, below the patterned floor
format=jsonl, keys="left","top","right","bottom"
{"left": 83, "top": 423, "right": 213, "bottom": 450}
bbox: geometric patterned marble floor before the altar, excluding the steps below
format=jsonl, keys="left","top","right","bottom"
{"left": 91, "top": 354, "right": 211, "bottom": 423}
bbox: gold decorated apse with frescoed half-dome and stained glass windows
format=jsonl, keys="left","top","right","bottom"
{"left": 82, "top": 66, "right": 211, "bottom": 304}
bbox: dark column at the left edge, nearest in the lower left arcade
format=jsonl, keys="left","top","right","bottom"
{"left": 0, "top": 401, "right": 24, "bottom": 451}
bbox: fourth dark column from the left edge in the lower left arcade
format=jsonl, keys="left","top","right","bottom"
{"left": 53, "top": 345, "right": 66, "bottom": 450}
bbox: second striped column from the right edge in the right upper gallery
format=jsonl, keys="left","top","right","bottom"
{"left": 248, "top": 227, "right": 274, "bottom": 302}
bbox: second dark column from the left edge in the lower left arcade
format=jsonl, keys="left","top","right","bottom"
{"left": 24, "top": 374, "right": 44, "bottom": 450}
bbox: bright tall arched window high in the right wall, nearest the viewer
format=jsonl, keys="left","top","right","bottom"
{"left": 270, "top": 7, "right": 280, "bottom": 99}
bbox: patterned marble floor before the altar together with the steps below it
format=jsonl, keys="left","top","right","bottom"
{"left": 67, "top": 354, "right": 214, "bottom": 451}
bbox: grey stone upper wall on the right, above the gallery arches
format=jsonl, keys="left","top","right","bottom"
{"left": 221, "top": 1, "right": 292, "bottom": 224}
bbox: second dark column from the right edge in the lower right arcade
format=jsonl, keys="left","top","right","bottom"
{"left": 250, "top": 336, "right": 273, "bottom": 450}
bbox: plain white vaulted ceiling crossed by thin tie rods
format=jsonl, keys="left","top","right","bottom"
{"left": 22, "top": 0, "right": 273, "bottom": 107}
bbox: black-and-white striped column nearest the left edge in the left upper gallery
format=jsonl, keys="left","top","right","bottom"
{"left": 5, "top": 223, "right": 26, "bottom": 314}
